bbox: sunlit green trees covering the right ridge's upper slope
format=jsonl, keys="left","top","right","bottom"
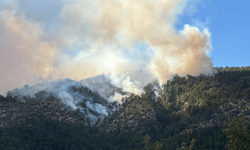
{"left": 158, "top": 67, "right": 250, "bottom": 116}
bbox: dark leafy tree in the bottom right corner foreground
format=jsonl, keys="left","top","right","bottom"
{"left": 223, "top": 114, "right": 250, "bottom": 150}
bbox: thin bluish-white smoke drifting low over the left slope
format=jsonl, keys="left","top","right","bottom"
{"left": 7, "top": 79, "right": 116, "bottom": 124}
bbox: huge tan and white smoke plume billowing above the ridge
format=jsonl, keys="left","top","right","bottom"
{"left": 0, "top": 0, "right": 213, "bottom": 95}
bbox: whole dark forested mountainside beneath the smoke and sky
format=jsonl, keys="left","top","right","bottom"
{"left": 0, "top": 67, "right": 250, "bottom": 150}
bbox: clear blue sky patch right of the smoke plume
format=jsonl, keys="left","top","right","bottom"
{"left": 176, "top": 0, "right": 250, "bottom": 67}
